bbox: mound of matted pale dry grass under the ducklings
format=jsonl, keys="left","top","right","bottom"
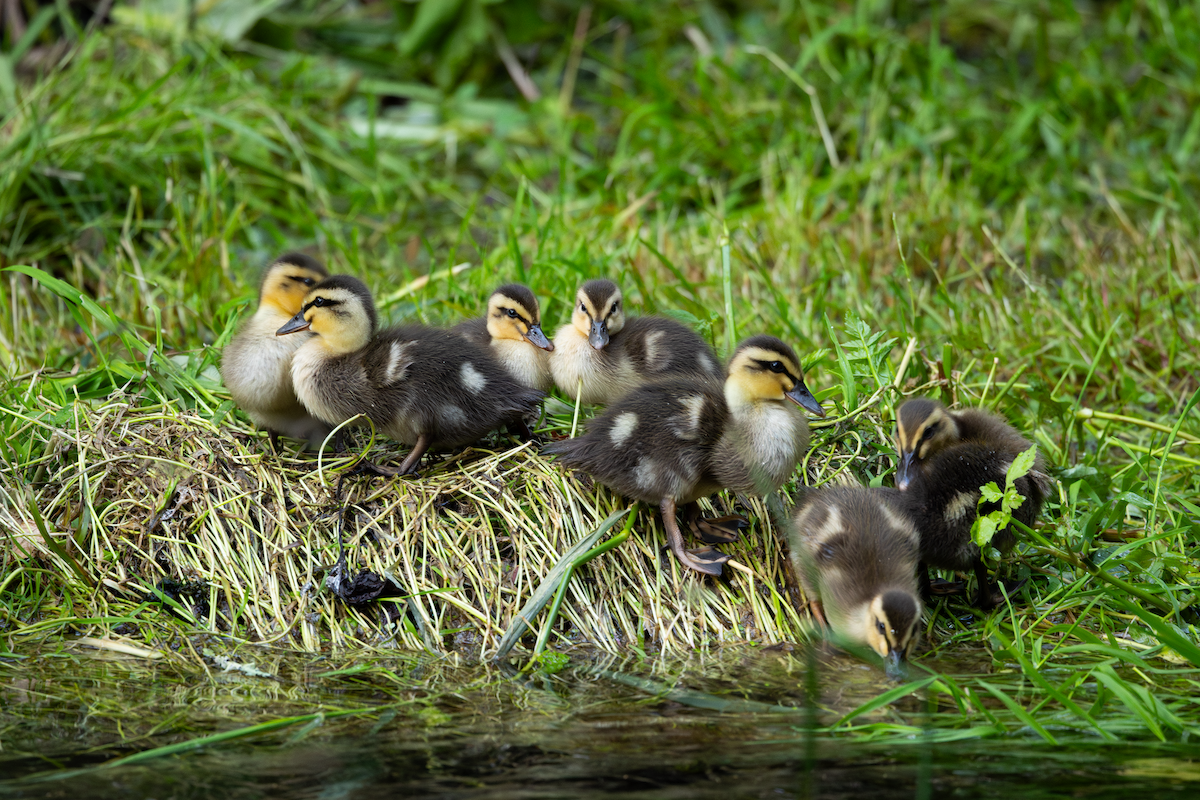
{"left": 0, "top": 386, "right": 882, "bottom": 657}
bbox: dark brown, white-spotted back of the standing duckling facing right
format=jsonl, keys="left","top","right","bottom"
{"left": 542, "top": 379, "right": 728, "bottom": 505}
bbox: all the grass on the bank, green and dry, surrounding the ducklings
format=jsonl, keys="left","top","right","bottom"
{"left": 0, "top": 0, "right": 1200, "bottom": 758}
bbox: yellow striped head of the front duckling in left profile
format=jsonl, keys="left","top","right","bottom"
{"left": 275, "top": 275, "right": 377, "bottom": 355}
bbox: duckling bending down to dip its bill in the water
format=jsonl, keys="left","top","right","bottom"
{"left": 791, "top": 486, "right": 922, "bottom": 678}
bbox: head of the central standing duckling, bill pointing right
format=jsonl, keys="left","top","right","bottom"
{"left": 725, "top": 336, "right": 824, "bottom": 416}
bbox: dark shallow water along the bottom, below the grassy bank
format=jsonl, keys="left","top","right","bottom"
{"left": 0, "top": 648, "right": 1200, "bottom": 800}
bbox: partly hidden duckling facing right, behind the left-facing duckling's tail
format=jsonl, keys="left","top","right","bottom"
{"left": 450, "top": 283, "right": 554, "bottom": 392}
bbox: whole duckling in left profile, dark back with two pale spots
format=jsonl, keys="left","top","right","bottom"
{"left": 277, "top": 275, "right": 545, "bottom": 474}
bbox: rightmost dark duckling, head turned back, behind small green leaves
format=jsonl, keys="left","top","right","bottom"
{"left": 896, "top": 398, "right": 1054, "bottom": 609}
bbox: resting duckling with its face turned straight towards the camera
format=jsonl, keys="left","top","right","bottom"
{"left": 550, "top": 278, "right": 720, "bottom": 404}
